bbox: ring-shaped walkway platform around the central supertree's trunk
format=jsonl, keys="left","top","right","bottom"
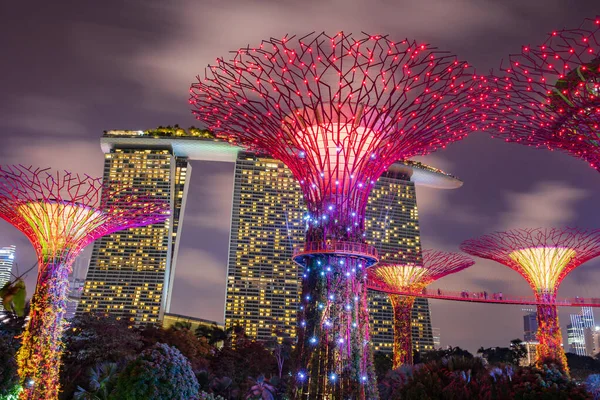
{"left": 292, "top": 241, "right": 379, "bottom": 268}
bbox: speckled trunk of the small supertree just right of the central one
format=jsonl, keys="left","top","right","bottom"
{"left": 390, "top": 295, "right": 415, "bottom": 369}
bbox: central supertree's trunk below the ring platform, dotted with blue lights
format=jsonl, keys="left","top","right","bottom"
{"left": 297, "top": 255, "right": 378, "bottom": 400}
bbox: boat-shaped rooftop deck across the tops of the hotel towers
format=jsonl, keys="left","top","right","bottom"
{"left": 100, "top": 128, "right": 463, "bottom": 189}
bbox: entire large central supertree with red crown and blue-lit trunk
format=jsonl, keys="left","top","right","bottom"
{"left": 190, "top": 33, "right": 490, "bottom": 399}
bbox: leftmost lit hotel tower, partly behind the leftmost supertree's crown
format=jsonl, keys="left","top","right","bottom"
{"left": 77, "top": 143, "right": 191, "bottom": 325}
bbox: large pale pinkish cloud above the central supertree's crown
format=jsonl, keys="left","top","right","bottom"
{"left": 94, "top": 0, "right": 551, "bottom": 109}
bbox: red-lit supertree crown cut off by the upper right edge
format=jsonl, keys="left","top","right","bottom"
{"left": 488, "top": 17, "right": 600, "bottom": 170}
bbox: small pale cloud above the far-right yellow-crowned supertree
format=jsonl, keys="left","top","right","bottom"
{"left": 497, "top": 181, "right": 590, "bottom": 230}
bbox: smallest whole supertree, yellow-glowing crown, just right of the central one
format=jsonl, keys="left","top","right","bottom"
{"left": 368, "top": 250, "right": 475, "bottom": 369}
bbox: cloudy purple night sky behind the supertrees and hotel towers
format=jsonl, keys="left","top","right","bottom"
{"left": 0, "top": 0, "right": 600, "bottom": 351}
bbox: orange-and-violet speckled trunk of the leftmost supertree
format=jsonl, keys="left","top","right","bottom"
{"left": 17, "top": 258, "right": 72, "bottom": 400}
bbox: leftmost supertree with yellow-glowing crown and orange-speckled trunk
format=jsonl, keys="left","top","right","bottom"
{"left": 0, "top": 166, "right": 169, "bottom": 400}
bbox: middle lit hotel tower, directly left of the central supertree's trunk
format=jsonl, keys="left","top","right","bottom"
{"left": 225, "top": 153, "right": 305, "bottom": 340}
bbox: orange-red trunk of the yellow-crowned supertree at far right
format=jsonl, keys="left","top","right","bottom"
{"left": 536, "top": 293, "right": 569, "bottom": 373}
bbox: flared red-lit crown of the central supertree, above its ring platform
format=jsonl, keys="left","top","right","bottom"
{"left": 190, "top": 33, "right": 484, "bottom": 241}
